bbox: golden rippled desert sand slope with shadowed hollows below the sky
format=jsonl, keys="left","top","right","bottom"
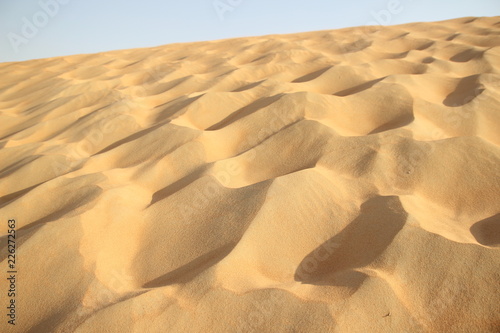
{"left": 0, "top": 17, "right": 500, "bottom": 333}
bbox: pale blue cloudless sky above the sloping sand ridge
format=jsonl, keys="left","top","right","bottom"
{"left": 0, "top": 0, "right": 500, "bottom": 62}
